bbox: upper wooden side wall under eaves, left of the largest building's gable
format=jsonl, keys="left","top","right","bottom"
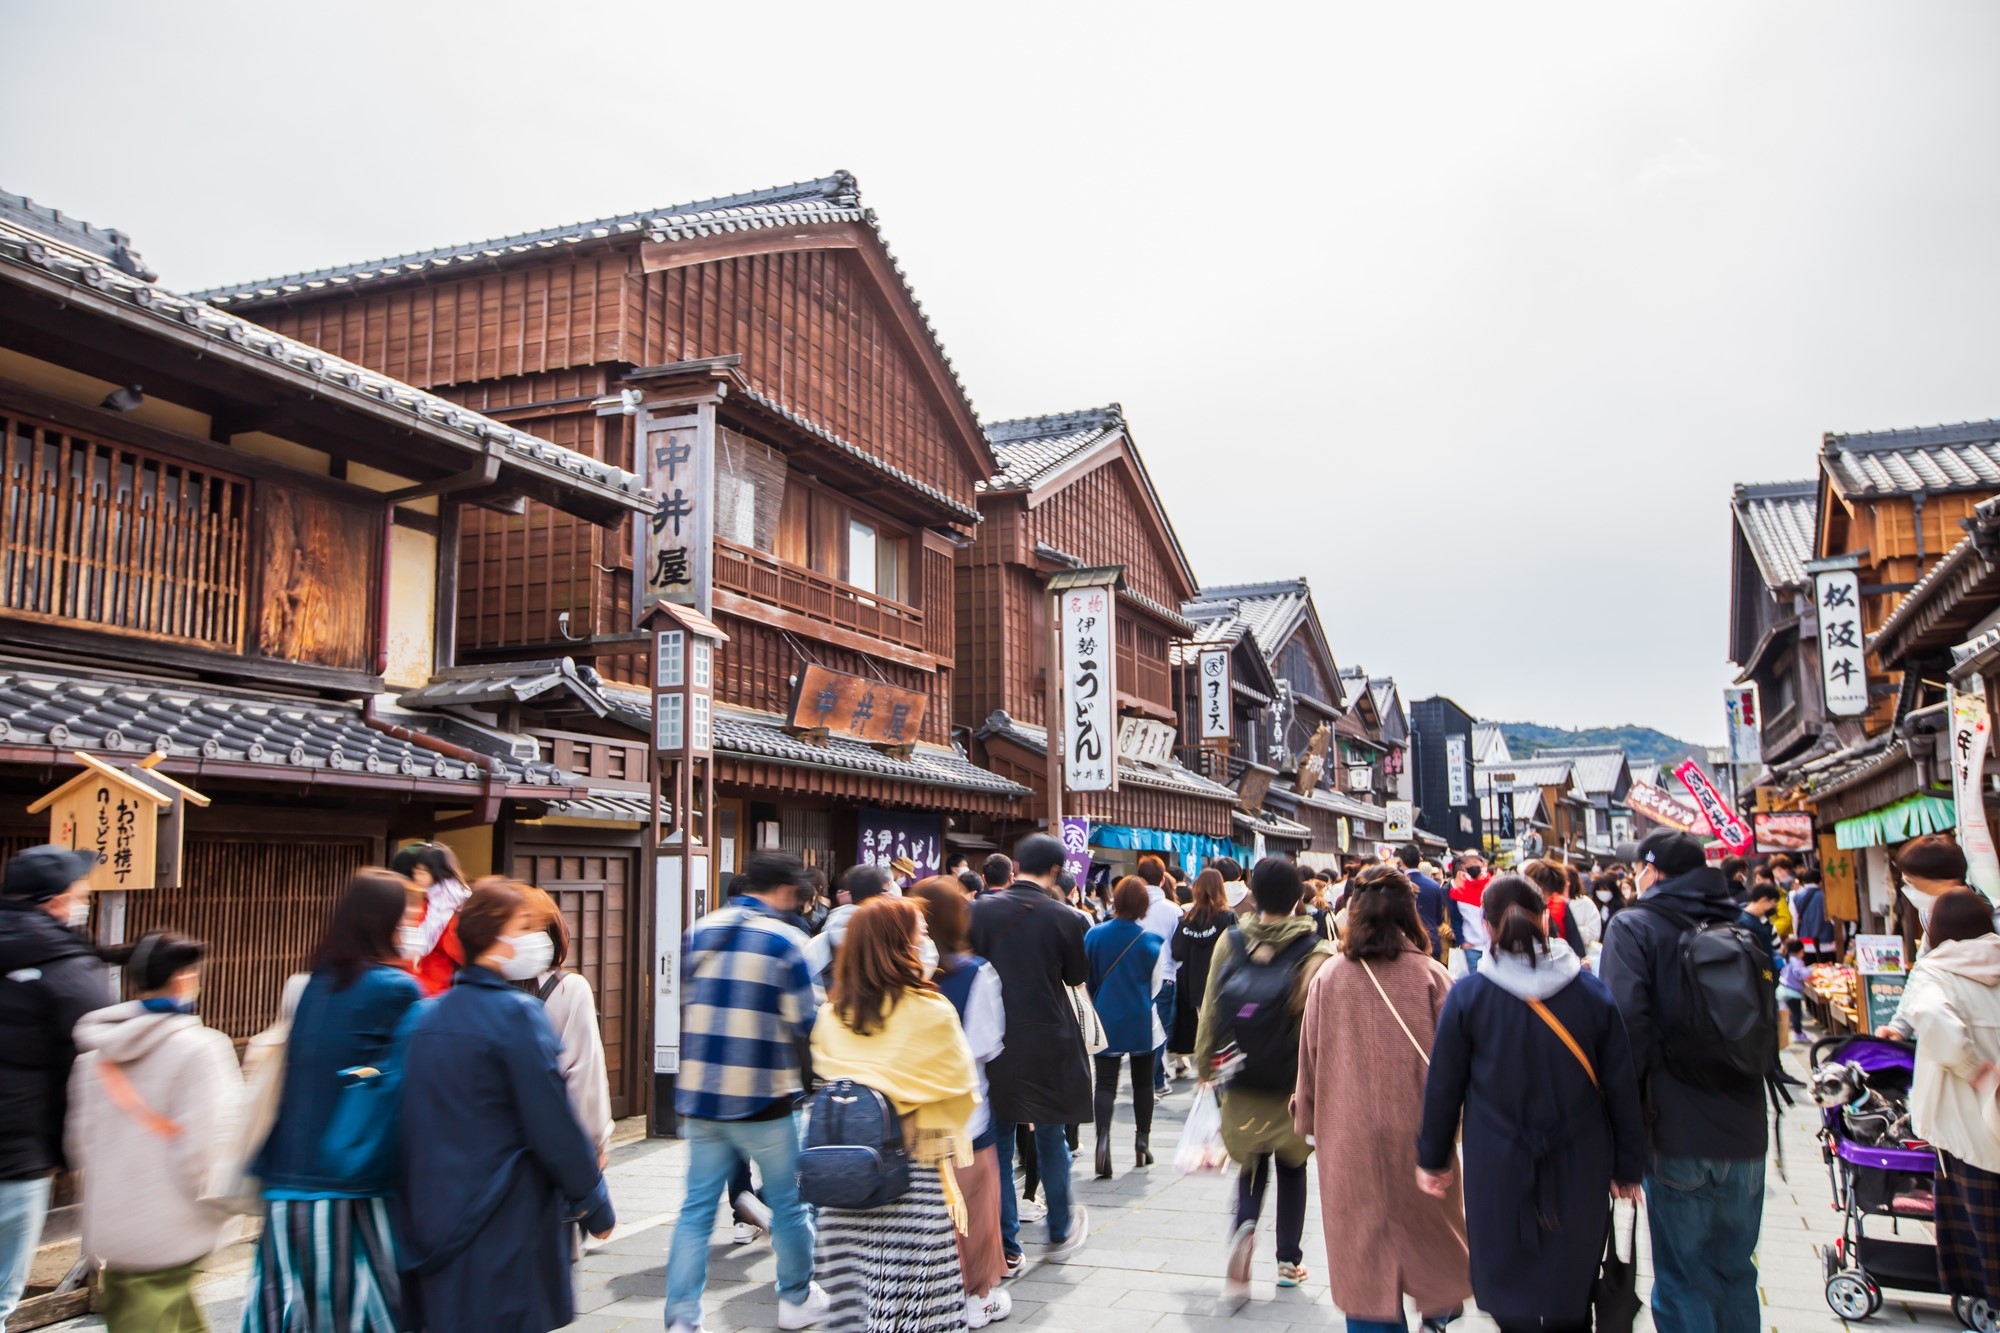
{"left": 258, "top": 250, "right": 636, "bottom": 388}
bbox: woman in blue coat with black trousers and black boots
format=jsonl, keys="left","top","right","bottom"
{"left": 1084, "top": 875, "right": 1166, "bottom": 1181}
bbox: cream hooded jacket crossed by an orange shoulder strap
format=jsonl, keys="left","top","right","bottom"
{"left": 64, "top": 1001, "right": 244, "bottom": 1273}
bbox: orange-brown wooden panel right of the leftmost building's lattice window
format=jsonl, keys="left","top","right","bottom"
{"left": 256, "top": 482, "right": 382, "bottom": 671}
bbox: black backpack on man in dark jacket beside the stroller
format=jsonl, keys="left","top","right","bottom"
{"left": 1632, "top": 899, "right": 1778, "bottom": 1091}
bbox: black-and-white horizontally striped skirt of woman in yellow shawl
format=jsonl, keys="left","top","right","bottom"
{"left": 814, "top": 1165, "right": 966, "bottom": 1333}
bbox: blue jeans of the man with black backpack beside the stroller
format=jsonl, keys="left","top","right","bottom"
{"left": 1646, "top": 1157, "right": 1764, "bottom": 1333}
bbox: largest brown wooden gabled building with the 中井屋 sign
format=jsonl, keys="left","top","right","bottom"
{"left": 208, "top": 174, "right": 1026, "bottom": 1112}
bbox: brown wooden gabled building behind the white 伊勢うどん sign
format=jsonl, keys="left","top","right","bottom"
{"left": 956, "top": 404, "right": 1248, "bottom": 869}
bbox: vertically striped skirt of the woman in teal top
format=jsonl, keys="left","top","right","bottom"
{"left": 242, "top": 1199, "right": 404, "bottom": 1333}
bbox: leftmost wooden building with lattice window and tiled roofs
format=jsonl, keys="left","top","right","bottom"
{"left": 0, "top": 196, "right": 650, "bottom": 1037}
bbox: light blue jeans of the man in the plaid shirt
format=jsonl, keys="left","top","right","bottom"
{"left": 666, "top": 1115, "right": 812, "bottom": 1327}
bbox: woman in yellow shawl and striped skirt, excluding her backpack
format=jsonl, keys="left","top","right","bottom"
{"left": 812, "top": 895, "right": 978, "bottom": 1333}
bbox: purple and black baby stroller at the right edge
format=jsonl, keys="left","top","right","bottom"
{"left": 1810, "top": 1035, "right": 1996, "bottom": 1333}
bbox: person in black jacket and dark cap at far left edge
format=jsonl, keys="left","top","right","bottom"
{"left": 0, "top": 847, "right": 118, "bottom": 1327}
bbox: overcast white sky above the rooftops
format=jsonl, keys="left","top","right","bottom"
{"left": 0, "top": 0, "right": 2000, "bottom": 739}
